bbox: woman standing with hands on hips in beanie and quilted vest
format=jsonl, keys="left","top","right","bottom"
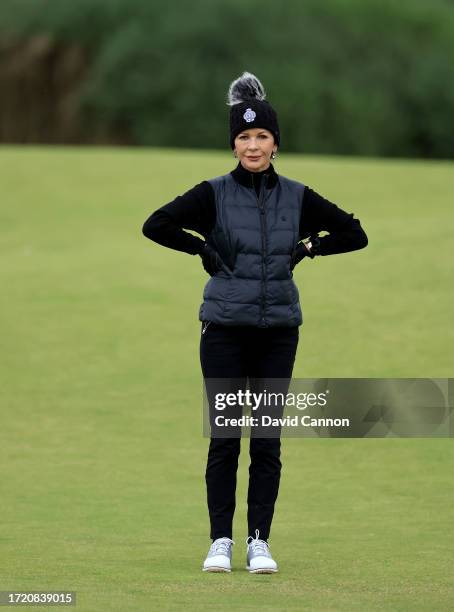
{"left": 143, "top": 72, "right": 367, "bottom": 573}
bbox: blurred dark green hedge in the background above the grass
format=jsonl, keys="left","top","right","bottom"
{"left": 0, "top": 0, "right": 454, "bottom": 157}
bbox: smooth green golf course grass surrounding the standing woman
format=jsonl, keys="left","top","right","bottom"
{"left": 0, "top": 147, "right": 454, "bottom": 611}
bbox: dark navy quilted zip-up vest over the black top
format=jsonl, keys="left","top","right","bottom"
{"left": 199, "top": 174, "right": 304, "bottom": 327}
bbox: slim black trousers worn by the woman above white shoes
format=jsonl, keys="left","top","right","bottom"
{"left": 200, "top": 323, "right": 299, "bottom": 540}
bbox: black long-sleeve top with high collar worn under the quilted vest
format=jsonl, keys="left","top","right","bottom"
{"left": 142, "top": 162, "right": 368, "bottom": 255}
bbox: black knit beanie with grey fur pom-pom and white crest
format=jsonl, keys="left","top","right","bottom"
{"left": 227, "top": 72, "right": 280, "bottom": 149}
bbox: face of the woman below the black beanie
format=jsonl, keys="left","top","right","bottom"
{"left": 233, "top": 128, "right": 277, "bottom": 172}
